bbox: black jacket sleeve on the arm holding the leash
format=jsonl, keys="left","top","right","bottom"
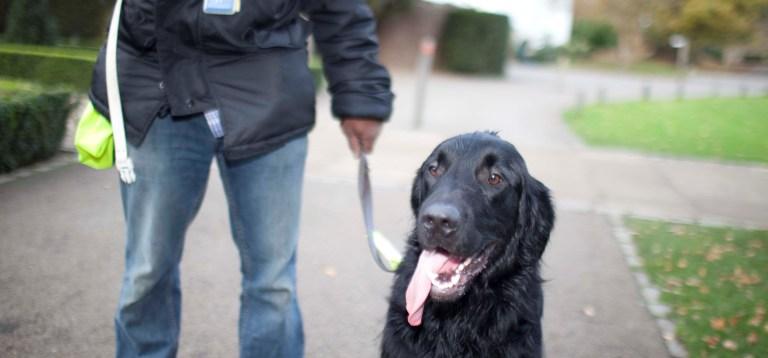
{"left": 308, "top": 0, "right": 394, "bottom": 120}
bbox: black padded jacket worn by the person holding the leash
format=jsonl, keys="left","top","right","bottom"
{"left": 90, "top": 0, "right": 393, "bottom": 159}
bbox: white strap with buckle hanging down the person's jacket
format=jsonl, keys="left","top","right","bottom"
{"left": 106, "top": 0, "right": 136, "bottom": 184}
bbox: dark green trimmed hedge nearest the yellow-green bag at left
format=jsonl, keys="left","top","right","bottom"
{"left": 0, "top": 90, "right": 73, "bottom": 173}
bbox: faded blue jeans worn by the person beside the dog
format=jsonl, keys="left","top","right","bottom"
{"left": 115, "top": 116, "right": 307, "bottom": 358}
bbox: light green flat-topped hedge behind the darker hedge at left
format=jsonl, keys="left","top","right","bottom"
{"left": 0, "top": 53, "right": 94, "bottom": 92}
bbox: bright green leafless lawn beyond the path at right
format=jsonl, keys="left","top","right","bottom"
{"left": 565, "top": 97, "right": 768, "bottom": 163}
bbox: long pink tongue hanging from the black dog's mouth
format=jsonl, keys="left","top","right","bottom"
{"left": 405, "top": 250, "right": 459, "bottom": 326}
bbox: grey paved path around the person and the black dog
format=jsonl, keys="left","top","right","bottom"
{"left": 0, "top": 68, "right": 768, "bottom": 357}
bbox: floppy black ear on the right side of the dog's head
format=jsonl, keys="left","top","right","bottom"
{"left": 516, "top": 175, "right": 555, "bottom": 265}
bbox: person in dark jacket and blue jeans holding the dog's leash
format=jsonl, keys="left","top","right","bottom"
{"left": 89, "top": 0, "right": 393, "bottom": 358}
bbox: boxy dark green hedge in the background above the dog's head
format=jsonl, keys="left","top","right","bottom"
{"left": 438, "top": 9, "right": 511, "bottom": 75}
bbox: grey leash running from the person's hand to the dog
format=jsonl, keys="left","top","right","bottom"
{"left": 357, "top": 153, "right": 403, "bottom": 272}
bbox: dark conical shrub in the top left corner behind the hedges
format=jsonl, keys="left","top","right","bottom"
{"left": 5, "top": 0, "right": 56, "bottom": 44}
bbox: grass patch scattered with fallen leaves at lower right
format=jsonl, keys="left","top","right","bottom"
{"left": 627, "top": 219, "right": 768, "bottom": 357}
